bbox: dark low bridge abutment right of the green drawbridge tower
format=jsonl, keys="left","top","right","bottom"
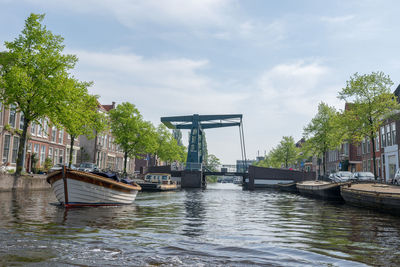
{"left": 244, "top": 166, "right": 316, "bottom": 190}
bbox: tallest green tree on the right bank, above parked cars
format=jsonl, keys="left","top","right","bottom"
{"left": 338, "top": 72, "right": 400, "bottom": 179}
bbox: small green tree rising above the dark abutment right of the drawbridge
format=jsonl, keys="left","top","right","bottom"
{"left": 271, "top": 136, "right": 298, "bottom": 168}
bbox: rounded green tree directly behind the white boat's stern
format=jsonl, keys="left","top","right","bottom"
{"left": 109, "top": 102, "right": 157, "bottom": 174}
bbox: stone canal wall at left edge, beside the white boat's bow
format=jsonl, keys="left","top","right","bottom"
{"left": 0, "top": 174, "right": 51, "bottom": 192}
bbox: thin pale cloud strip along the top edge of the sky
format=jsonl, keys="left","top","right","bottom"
{"left": 26, "top": 0, "right": 235, "bottom": 27}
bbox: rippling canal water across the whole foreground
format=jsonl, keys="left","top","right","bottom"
{"left": 0, "top": 184, "right": 400, "bottom": 266}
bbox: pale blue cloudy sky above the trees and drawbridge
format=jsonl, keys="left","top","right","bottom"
{"left": 0, "top": 0, "right": 400, "bottom": 164}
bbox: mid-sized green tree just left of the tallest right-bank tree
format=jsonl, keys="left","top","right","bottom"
{"left": 302, "top": 102, "right": 343, "bottom": 174}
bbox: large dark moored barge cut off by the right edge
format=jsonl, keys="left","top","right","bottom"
{"left": 341, "top": 183, "right": 400, "bottom": 215}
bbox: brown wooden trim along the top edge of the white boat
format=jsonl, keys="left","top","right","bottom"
{"left": 47, "top": 170, "right": 141, "bottom": 193}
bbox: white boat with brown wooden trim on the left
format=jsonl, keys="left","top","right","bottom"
{"left": 47, "top": 169, "right": 141, "bottom": 207}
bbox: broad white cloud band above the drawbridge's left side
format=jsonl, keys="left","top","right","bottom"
{"left": 69, "top": 51, "right": 246, "bottom": 122}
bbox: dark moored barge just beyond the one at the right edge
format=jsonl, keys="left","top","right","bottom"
{"left": 296, "top": 181, "right": 346, "bottom": 200}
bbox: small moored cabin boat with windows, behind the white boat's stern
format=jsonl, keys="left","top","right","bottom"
{"left": 137, "top": 173, "right": 179, "bottom": 191}
